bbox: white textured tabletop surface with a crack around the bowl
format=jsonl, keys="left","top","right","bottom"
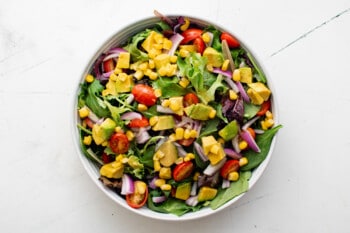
{"left": 0, "top": 0, "right": 350, "bottom": 233}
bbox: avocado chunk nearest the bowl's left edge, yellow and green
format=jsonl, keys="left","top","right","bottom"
{"left": 92, "top": 118, "right": 117, "bottom": 145}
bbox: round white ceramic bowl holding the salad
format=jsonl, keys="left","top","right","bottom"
{"left": 73, "top": 16, "right": 278, "bottom": 221}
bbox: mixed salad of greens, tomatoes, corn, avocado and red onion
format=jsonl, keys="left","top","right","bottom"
{"left": 77, "top": 13, "right": 282, "bottom": 216}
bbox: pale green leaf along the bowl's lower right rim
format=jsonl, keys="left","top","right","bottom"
{"left": 210, "top": 171, "right": 251, "bottom": 210}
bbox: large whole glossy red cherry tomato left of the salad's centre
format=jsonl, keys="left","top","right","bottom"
{"left": 131, "top": 84, "right": 157, "bottom": 106}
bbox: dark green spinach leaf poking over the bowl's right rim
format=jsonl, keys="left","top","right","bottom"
{"left": 241, "top": 125, "right": 282, "bottom": 171}
